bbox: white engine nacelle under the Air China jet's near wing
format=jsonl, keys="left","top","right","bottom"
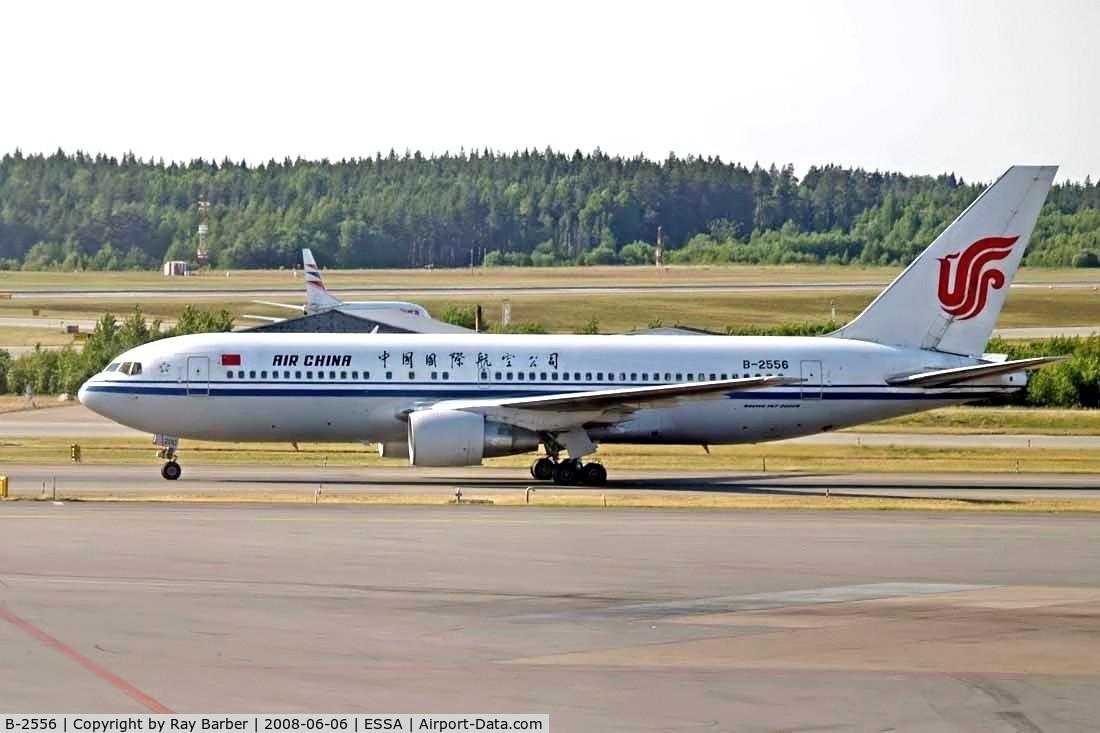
{"left": 408, "top": 409, "right": 540, "bottom": 466}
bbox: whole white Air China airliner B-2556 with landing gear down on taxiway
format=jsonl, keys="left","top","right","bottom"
{"left": 80, "top": 166, "right": 1057, "bottom": 484}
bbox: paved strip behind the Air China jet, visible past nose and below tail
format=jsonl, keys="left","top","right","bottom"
{"left": 0, "top": 404, "right": 1100, "bottom": 450}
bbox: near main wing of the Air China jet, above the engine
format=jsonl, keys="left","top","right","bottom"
{"left": 431, "top": 376, "right": 802, "bottom": 430}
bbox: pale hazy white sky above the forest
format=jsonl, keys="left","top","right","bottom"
{"left": 0, "top": 0, "right": 1100, "bottom": 179}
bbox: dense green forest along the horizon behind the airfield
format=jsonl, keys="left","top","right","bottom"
{"left": 0, "top": 150, "right": 1100, "bottom": 271}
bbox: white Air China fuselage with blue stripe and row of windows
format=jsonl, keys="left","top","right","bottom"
{"left": 80, "top": 333, "right": 1026, "bottom": 445}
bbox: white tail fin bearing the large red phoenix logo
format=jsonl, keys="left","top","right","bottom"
{"left": 832, "top": 165, "right": 1058, "bottom": 355}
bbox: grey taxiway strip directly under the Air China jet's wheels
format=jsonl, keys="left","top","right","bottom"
{"left": 0, "top": 460, "right": 1100, "bottom": 504}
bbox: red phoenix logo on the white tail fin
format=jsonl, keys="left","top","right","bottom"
{"left": 939, "top": 237, "right": 1020, "bottom": 320}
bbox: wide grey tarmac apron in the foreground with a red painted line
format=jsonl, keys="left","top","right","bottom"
{"left": 0, "top": 503, "right": 1100, "bottom": 731}
